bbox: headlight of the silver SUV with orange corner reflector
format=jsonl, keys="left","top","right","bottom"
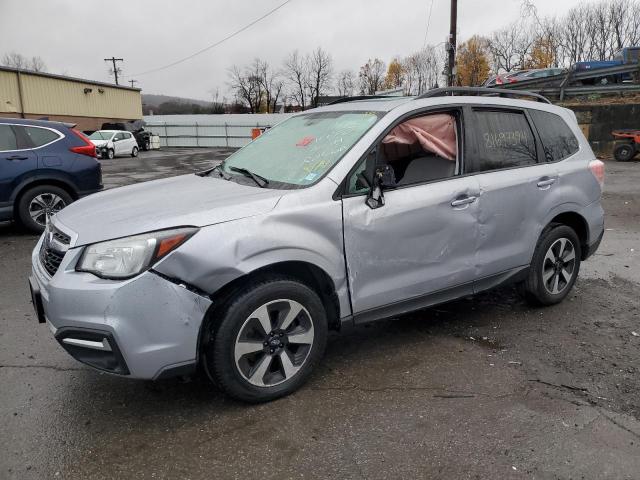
{"left": 76, "top": 227, "right": 198, "bottom": 279}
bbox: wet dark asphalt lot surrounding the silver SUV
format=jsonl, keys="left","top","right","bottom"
{"left": 0, "top": 150, "right": 640, "bottom": 479}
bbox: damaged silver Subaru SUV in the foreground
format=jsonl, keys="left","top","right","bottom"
{"left": 30, "top": 89, "right": 604, "bottom": 402}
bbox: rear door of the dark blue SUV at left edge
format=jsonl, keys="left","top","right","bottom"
{"left": 0, "top": 124, "right": 38, "bottom": 203}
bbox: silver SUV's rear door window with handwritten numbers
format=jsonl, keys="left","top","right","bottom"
{"left": 466, "top": 110, "right": 537, "bottom": 172}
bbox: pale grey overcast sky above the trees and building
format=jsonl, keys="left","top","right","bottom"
{"left": 0, "top": 0, "right": 584, "bottom": 100}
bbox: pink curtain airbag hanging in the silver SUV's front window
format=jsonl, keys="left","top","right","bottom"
{"left": 382, "top": 113, "right": 458, "bottom": 162}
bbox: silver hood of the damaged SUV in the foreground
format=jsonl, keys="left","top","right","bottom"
{"left": 52, "top": 174, "right": 282, "bottom": 246}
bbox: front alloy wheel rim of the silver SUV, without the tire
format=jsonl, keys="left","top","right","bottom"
{"left": 234, "top": 299, "right": 314, "bottom": 387}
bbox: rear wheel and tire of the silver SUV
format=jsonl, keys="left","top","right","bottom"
{"left": 520, "top": 224, "right": 582, "bottom": 305}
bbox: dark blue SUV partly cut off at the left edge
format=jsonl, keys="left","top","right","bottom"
{"left": 0, "top": 118, "right": 102, "bottom": 233}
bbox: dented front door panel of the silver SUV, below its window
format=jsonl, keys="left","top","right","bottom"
{"left": 342, "top": 176, "right": 480, "bottom": 322}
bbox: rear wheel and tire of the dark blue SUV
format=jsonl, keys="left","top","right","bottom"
{"left": 18, "top": 185, "right": 73, "bottom": 233}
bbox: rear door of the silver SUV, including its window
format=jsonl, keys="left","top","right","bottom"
{"left": 465, "top": 107, "right": 558, "bottom": 289}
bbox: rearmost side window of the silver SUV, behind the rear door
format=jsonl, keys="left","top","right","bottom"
{"left": 529, "top": 110, "right": 580, "bottom": 162}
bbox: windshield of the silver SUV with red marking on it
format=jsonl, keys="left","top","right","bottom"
{"left": 218, "top": 111, "right": 383, "bottom": 188}
